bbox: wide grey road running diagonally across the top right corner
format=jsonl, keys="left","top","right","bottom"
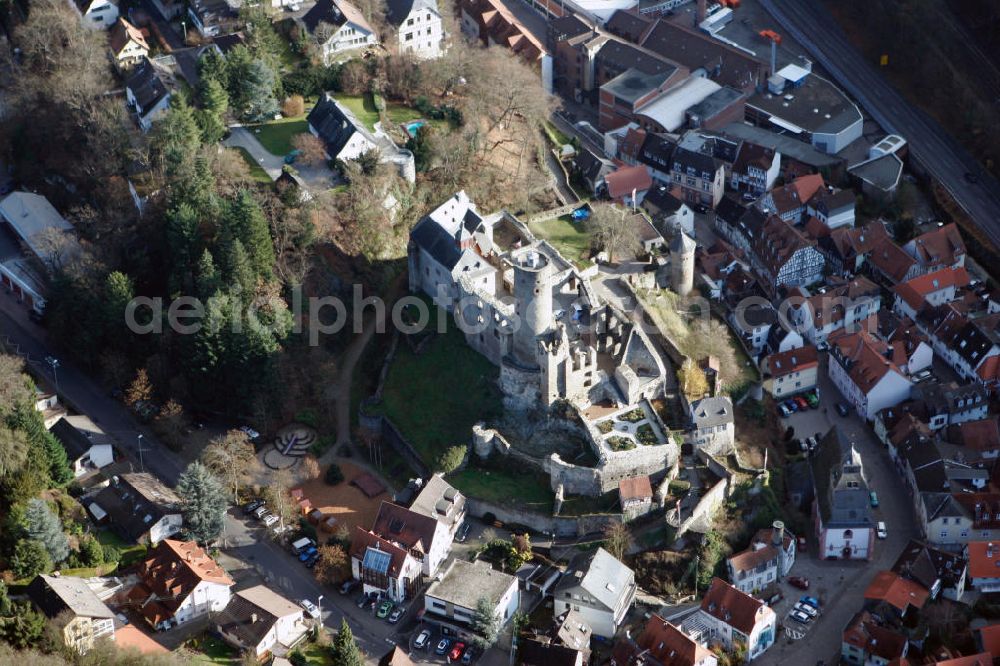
{"left": 760, "top": 0, "right": 1000, "bottom": 248}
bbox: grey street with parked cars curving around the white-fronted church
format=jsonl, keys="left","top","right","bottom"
{"left": 757, "top": 354, "right": 918, "bottom": 665}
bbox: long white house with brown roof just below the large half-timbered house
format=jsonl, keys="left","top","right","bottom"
{"left": 788, "top": 276, "right": 881, "bottom": 345}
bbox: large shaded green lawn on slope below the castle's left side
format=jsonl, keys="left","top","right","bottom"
{"left": 376, "top": 313, "right": 501, "bottom": 467}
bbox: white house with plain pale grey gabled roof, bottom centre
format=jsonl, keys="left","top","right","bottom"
{"left": 553, "top": 547, "right": 637, "bottom": 638}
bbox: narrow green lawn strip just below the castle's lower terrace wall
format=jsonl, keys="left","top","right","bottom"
{"left": 448, "top": 454, "right": 555, "bottom": 508}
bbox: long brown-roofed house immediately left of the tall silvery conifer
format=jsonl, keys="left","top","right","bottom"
{"left": 87, "top": 472, "right": 184, "bottom": 546}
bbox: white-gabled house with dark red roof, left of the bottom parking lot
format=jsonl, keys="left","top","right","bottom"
{"left": 681, "top": 578, "right": 778, "bottom": 661}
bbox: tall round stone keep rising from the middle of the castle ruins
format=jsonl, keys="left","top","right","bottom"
{"left": 511, "top": 247, "right": 552, "bottom": 366}
